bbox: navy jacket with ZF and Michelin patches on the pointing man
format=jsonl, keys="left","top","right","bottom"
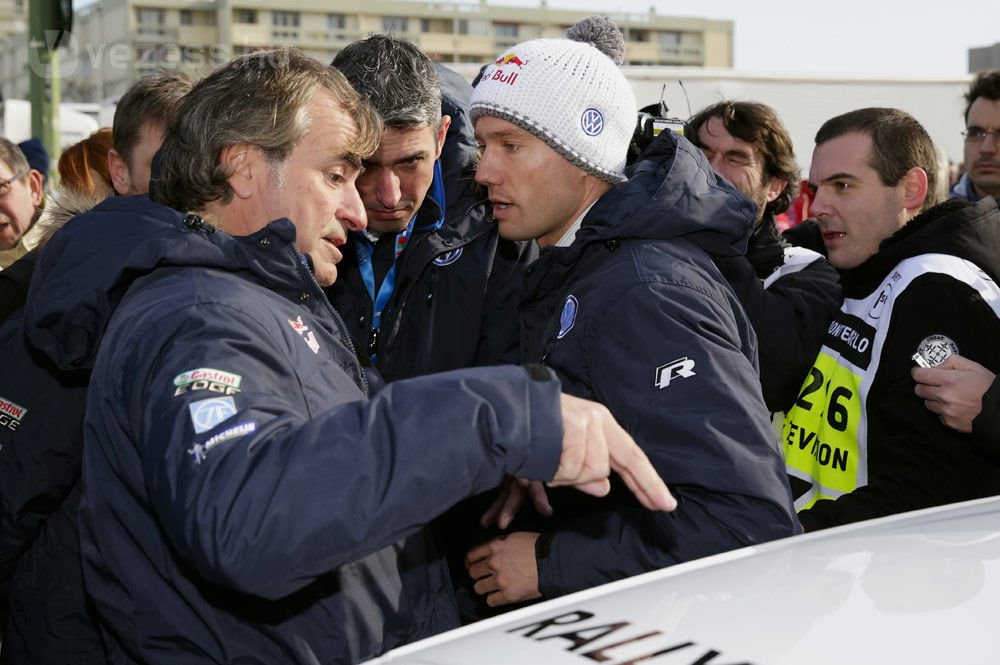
{"left": 15, "top": 197, "right": 562, "bottom": 663}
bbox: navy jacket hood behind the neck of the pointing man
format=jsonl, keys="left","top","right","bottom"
{"left": 24, "top": 196, "right": 305, "bottom": 370}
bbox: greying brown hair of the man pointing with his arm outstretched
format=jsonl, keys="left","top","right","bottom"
{"left": 153, "top": 48, "right": 382, "bottom": 211}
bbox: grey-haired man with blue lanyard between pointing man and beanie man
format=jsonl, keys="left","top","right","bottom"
{"left": 327, "top": 35, "right": 536, "bottom": 381}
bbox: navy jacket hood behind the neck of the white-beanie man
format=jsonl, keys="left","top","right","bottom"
{"left": 573, "top": 131, "right": 756, "bottom": 256}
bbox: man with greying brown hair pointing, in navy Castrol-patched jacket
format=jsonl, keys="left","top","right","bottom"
{"left": 4, "top": 49, "right": 672, "bottom": 663}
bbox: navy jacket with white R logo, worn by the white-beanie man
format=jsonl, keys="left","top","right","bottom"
{"left": 521, "top": 132, "right": 798, "bottom": 597}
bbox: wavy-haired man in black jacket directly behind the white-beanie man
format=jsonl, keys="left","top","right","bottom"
{"left": 685, "top": 101, "right": 841, "bottom": 411}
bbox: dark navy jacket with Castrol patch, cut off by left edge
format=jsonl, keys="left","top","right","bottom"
{"left": 0, "top": 310, "right": 96, "bottom": 665}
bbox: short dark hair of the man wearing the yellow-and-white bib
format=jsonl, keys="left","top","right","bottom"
{"left": 816, "top": 108, "right": 942, "bottom": 210}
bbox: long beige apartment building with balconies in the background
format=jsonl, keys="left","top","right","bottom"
{"left": 0, "top": 0, "right": 733, "bottom": 102}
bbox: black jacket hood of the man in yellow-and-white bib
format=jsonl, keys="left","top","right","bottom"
{"left": 841, "top": 197, "right": 1000, "bottom": 298}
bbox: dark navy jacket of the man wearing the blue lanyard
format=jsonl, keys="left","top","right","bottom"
{"left": 326, "top": 67, "right": 537, "bottom": 381}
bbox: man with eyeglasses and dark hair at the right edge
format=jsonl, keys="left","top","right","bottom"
{"left": 951, "top": 69, "right": 1000, "bottom": 202}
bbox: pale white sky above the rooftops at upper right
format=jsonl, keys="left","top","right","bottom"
{"left": 488, "top": 0, "right": 1000, "bottom": 75}
